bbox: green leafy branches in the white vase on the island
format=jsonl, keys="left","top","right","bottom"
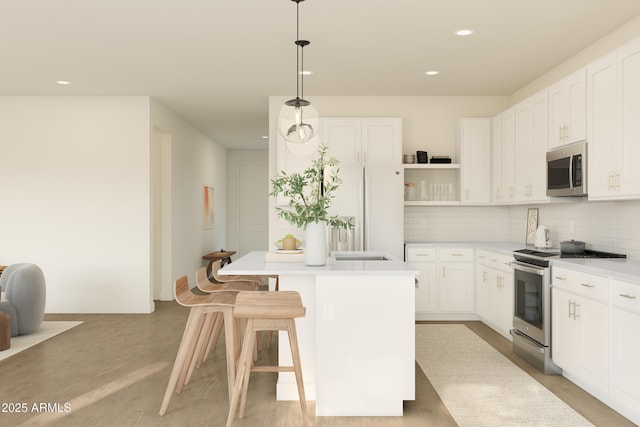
{"left": 269, "top": 145, "right": 353, "bottom": 228}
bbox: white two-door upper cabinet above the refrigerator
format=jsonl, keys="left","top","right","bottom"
{"left": 320, "top": 118, "right": 402, "bottom": 166}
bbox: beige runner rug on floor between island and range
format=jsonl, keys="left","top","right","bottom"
{"left": 416, "top": 324, "right": 592, "bottom": 427}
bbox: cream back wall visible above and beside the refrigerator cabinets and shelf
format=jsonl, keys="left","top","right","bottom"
{"left": 269, "top": 96, "right": 508, "bottom": 246}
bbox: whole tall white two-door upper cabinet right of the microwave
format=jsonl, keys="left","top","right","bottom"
{"left": 587, "top": 39, "right": 640, "bottom": 200}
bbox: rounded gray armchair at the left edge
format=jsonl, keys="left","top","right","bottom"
{"left": 0, "top": 263, "right": 46, "bottom": 337}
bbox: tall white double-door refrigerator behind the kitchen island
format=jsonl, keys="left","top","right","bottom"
{"left": 329, "top": 163, "right": 404, "bottom": 259}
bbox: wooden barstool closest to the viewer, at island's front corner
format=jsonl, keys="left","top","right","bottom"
{"left": 227, "top": 291, "right": 309, "bottom": 427}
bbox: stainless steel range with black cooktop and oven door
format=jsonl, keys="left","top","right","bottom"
{"left": 511, "top": 249, "right": 626, "bottom": 374}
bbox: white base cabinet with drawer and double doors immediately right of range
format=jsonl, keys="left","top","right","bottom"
{"left": 551, "top": 266, "right": 609, "bottom": 395}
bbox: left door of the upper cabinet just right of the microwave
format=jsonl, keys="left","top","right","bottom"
{"left": 587, "top": 53, "right": 621, "bottom": 200}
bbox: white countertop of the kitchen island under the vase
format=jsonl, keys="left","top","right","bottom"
{"left": 220, "top": 251, "right": 418, "bottom": 276}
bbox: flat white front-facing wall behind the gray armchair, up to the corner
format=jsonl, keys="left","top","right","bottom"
{"left": 0, "top": 97, "right": 153, "bottom": 313}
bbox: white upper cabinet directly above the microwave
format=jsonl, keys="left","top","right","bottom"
{"left": 549, "top": 68, "right": 587, "bottom": 149}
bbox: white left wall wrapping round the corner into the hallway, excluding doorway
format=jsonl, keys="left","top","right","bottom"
{"left": 0, "top": 96, "right": 227, "bottom": 313}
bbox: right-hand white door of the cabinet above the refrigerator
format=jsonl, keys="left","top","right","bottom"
{"left": 362, "top": 118, "right": 402, "bottom": 165}
